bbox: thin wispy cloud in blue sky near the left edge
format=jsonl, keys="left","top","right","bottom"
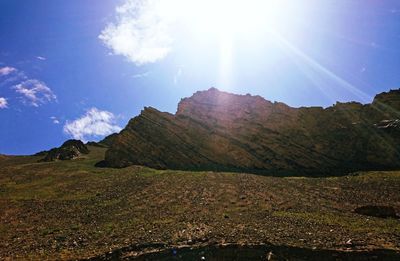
{"left": 14, "top": 79, "right": 57, "bottom": 107}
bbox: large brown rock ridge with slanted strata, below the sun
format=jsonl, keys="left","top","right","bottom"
{"left": 105, "top": 88, "right": 400, "bottom": 174}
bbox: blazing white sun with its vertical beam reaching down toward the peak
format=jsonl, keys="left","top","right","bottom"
{"left": 168, "top": 0, "right": 297, "bottom": 87}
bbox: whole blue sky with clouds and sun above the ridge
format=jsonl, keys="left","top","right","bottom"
{"left": 0, "top": 0, "right": 400, "bottom": 154}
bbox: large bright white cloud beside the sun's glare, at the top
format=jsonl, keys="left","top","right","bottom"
{"left": 99, "top": 0, "right": 174, "bottom": 65}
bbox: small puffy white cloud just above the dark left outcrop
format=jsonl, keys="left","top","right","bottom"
{"left": 64, "top": 108, "right": 121, "bottom": 141}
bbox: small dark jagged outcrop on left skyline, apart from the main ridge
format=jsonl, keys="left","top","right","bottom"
{"left": 38, "top": 140, "right": 89, "bottom": 162}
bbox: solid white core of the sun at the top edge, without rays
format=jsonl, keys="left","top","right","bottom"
{"left": 176, "top": 0, "right": 291, "bottom": 36}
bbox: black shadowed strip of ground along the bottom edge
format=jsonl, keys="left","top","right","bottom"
{"left": 81, "top": 244, "right": 400, "bottom": 261}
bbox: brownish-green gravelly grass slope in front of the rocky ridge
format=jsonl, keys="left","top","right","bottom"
{"left": 0, "top": 147, "right": 400, "bottom": 259}
